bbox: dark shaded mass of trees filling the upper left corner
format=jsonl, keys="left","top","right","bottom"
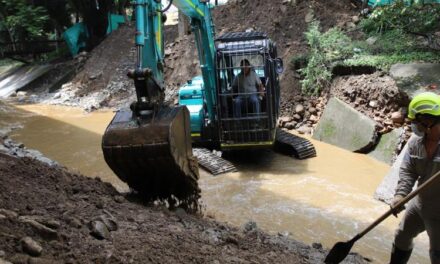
{"left": 0, "top": 0, "right": 130, "bottom": 61}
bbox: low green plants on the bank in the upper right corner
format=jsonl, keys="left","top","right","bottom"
{"left": 360, "top": 0, "right": 440, "bottom": 33}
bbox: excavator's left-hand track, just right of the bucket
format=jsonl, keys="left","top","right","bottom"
{"left": 193, "top": 148, "right": 237, "bottom": 175}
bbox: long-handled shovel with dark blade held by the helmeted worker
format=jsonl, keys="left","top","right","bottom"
{"left": 324, "top": 171, "right": 440, "bottom": 264}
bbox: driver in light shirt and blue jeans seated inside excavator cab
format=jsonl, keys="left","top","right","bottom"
{"left": 232, "top": 59, "right": 264, "bottom": 117}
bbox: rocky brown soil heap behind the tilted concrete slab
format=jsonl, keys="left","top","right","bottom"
{"left": 280, "top": 72, "right": 410, "bottom": 138}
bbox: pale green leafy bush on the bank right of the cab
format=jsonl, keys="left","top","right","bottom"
{"left": 300, "top": 22, "right": 353, "bottom": 94}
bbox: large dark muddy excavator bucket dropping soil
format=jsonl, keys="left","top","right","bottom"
{"left": 102, "top": 106, "right": 200, "bottom": 206}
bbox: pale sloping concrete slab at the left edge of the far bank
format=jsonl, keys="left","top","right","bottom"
{"left": 0, "top": 65, "right": 53, "bottom": 98}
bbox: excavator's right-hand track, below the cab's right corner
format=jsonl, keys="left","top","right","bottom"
{"left": 275, "top": 129, "right": 316, "bottom": 159}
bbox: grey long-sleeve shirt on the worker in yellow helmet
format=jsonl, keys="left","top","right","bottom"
{"left": 395, "top": 134, "right": 440, "bottom": 217}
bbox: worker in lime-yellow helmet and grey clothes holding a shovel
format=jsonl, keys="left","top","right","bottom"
{"left": 390, "top": 92, "right": 440, "bottom": 264}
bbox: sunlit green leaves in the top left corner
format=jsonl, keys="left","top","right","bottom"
{"left": 0, "top": 0, "right": 49, "bottom": 42}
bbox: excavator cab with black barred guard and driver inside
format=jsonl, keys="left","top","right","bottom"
{"left": 216, "top": 32, "right": 282, "bottom": 149}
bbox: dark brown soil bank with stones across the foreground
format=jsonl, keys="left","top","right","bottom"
{"left": 0, "top": 148, "right": 365, "bottom": 263}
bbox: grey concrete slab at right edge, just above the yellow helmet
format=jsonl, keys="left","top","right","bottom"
{"left": 390, "top": 63, "right": 440, "bottom": 98}
